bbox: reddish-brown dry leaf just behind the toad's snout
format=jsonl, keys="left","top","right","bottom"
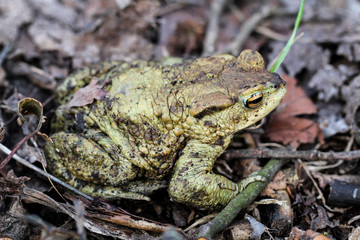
{"left": 266, "top": 76, "right": 324, "bottom": 148}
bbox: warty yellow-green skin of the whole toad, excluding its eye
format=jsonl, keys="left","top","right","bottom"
{"left": 45, "top": 50, "right": 286, "bottom": 208}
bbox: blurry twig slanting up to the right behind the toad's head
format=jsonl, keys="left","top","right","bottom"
{"left": 221, "top": 5, "right": 275, "bottom": 56}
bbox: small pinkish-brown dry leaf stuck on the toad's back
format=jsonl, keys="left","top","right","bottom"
{"left": 67, "top": 77, "right": 108, "bottom": 108}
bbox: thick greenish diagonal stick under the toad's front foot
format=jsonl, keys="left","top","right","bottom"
{"left": 197, "top": 159, "right": 289, "bottom": 239}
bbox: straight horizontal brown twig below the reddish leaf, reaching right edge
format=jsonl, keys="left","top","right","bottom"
{"left": 225, "top": 148, "right": 360, "bottom": 161}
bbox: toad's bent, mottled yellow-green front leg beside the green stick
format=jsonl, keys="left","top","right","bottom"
{"left": 169, "top": 139, "right": 240, "bottom": 209}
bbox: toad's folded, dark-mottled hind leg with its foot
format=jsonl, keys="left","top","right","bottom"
{"left": 45, "top": 132, "right": 155, "bottom": 200}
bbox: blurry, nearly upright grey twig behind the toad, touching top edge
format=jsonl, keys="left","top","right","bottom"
{"left": 202, "top": 0, "right": 228, "bottom": 56}
